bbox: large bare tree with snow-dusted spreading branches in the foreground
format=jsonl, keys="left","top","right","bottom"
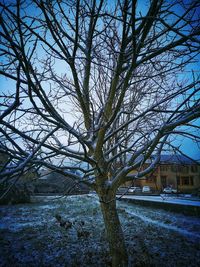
{"left": 0, "top": 0, "right": 200, "bottom": 266}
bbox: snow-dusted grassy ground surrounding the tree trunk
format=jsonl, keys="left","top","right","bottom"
{"left": 0, "top": 194, "right": 200, "bottom": 267}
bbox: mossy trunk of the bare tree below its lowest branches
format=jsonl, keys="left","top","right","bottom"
{"left": 100, "top": 196, "right": 128, "bottom": 267}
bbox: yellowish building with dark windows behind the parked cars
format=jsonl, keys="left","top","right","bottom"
{"left": 128, "top": 155, "right": 200, "bottom": 193}
